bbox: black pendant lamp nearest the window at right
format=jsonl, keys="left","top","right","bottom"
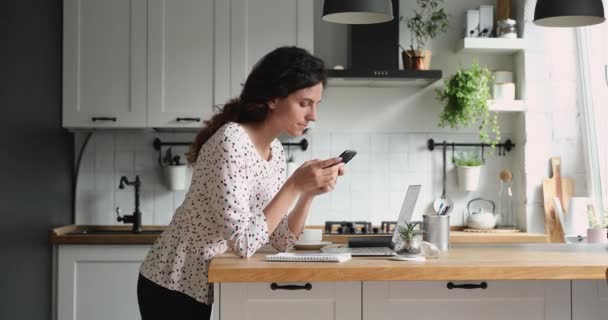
{"left": 534, "top": 0, "right": 606, "bottom": 27}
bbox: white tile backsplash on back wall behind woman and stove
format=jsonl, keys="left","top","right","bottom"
{"left": 76, "top": 131, "right": 509, "bottom": 225}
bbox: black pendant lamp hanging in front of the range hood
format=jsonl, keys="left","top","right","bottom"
{"left": 323, "top": 0, "right": 393, "bottom": 24}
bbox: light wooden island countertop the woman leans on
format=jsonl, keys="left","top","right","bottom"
{"left": 209, "top": 243, "right": 608, "bottom": 282}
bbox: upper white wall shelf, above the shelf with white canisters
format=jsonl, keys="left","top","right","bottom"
{"left": 457, "top": 38, "right": 525, "bottom": 54}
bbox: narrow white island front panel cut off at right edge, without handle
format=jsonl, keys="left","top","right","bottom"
{"left": 572, "top": 280, "right": 608, "bottom": 320}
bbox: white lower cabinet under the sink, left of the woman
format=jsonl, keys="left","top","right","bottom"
{"left": 55, "top": 245, "right": 150, "bottom": 320}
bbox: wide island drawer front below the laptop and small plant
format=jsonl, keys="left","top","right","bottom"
{"left": 363, "top": 280, "right": 570, "bottom": 320}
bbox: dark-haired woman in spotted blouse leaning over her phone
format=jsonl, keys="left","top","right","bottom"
{"left": 137, "top": 47, "right": 344, "bottom": 320}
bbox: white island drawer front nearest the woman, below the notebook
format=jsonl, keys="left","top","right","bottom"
{"left": 220, "top": 282, "right": 361, "bottom": 320}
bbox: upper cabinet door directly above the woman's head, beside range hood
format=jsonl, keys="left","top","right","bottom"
{"left": 230, "top": 0, "right": 314, "bottom": 96}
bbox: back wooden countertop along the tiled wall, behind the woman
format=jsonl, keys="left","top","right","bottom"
{"left": 49, "top": 225, "right": 547, "bottom": 244}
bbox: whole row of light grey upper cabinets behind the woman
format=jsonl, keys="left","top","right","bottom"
{"left": 63, "top": 0, "right": 313, "bottom": 128}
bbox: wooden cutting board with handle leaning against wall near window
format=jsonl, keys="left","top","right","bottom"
{"left": 543, "top": 157, "right": 574, "bottom": 242}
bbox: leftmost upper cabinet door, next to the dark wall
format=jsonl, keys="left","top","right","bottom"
{"left": 63, "top": 0, "right": 147, "bottom": 128}
